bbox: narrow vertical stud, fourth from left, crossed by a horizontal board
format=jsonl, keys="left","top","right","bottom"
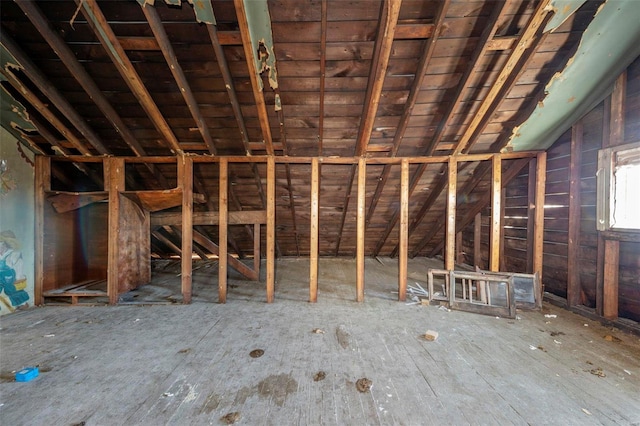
{"left": 218, "top": 157, "right": 229, "bottom": 303}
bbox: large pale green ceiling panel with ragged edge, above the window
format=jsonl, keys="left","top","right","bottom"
{"left": 505, "top": 0, "right": 640, "bottom": 151}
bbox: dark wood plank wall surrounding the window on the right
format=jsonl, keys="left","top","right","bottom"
{"left": 462, "top": 58, "right": 640, "bottom": 321}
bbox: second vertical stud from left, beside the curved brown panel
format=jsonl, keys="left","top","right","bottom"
{"left": 104, "top": 157, "right": 125, "bottom": 305}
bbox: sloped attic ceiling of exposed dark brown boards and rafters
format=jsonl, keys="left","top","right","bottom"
{"left": 0, "top": 0, "right": 633, "bottom": 257}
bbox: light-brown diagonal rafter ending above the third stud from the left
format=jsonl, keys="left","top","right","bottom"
{"left": 76, "top": 0, "right": 182, "bottom": 154}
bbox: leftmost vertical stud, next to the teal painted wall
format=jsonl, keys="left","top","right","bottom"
{"left": 33, "top": 155, "right": 49, "bottom": 305}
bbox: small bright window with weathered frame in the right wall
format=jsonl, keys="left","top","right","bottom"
{"left": 597, "top": 143, "right": 640, "bottom": 231}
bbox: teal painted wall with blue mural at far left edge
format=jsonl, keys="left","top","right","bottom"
{"left": 0, "top": 128, "right": 35, "bottom": 315}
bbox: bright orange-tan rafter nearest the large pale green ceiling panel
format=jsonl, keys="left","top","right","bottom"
{"left": 454, "top": 0, "right": 550, "bottom": 154}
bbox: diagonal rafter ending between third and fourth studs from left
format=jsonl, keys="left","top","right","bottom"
{"left": 141, "top": 3, "right": 217, "bottom": 155}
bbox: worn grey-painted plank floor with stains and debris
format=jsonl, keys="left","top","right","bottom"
{"left": 0, "top": 259, "right": 640, "bottom": 425}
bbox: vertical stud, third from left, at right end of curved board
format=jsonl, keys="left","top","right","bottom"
{"left": 178, "top": 155, "right": 193, "bottom": 303}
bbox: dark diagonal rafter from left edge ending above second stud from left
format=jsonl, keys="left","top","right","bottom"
{"left": 0, "top": 28, "right": 110, "bottom": 154}
